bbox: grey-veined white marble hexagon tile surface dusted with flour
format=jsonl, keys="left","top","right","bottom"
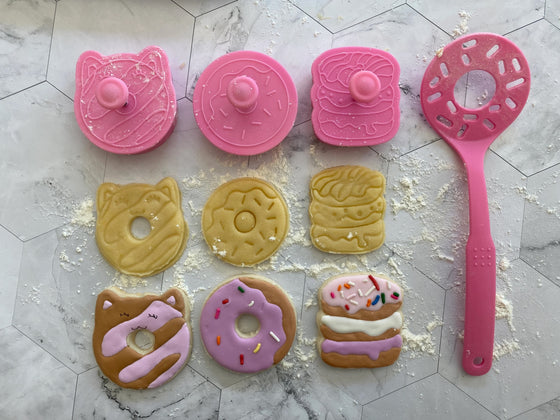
{"left": 0, "top": 0, "right": 560, "bottom": 420}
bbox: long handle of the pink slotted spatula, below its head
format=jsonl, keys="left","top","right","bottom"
{"left": 463, "top": 154, "right": 496, "bottom": 375}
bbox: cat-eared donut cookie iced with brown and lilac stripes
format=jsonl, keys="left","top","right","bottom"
{"left": 93, "top": 287, "right": 192, "bottom": 389}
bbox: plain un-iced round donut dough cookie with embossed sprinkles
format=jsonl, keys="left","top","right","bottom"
{"left": 202, "top": 178, "right": 289, "bottom": 266}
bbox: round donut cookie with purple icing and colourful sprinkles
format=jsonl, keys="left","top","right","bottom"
{"left": 200, "top": 276, "right": 296, "bottom": 373}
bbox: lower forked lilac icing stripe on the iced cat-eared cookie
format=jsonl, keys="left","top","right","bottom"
{"left": 119, "top": 324, "right": 190, "bottom": 388}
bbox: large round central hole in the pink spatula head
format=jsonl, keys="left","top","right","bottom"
{"left": 453, "top": 70, "right": 496, "bottom": 109}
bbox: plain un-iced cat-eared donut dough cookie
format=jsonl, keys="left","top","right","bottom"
{"left": 95, "top": 178, "right": 188, "bottom": 277}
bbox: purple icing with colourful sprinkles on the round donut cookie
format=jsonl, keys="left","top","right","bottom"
{"left": 200, "top": 279, "right": 286, "bottom": 372}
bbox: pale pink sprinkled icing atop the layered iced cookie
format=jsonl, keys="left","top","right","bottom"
{"left": 321, "top": 274, "right": 402, "bottom": 314}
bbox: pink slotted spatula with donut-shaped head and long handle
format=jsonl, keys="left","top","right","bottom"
{"left": 420, "top": 33, "right": 530, "bottom": 375}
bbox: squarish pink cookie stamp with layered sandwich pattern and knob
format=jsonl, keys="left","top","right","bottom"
{"left": 311, "top": 47, "right": 400, "bottom": 146}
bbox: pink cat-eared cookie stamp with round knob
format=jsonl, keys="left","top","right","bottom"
{"left": 74, "top": 46, "right": 177, "bottom": 154}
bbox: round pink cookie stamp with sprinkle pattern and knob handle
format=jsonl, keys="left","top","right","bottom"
{"left": 193, "top": 51, "right": 297, "bottom": 155}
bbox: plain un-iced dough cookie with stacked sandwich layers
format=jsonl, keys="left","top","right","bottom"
{"left": 309, "top": 166, "right": 385, "bottom": 254}
